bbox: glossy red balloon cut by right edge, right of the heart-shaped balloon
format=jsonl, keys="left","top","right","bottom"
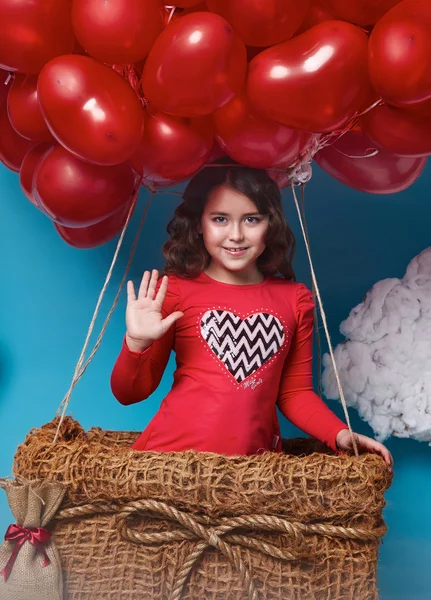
{"left": 369, "top": 0, "right": 431, "bottom": 106}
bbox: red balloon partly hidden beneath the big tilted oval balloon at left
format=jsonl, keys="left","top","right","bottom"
{"left": 33, "top": 146, "right": 135, "bottom": 227}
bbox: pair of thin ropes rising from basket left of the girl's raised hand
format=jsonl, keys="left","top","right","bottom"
{"left": 53, "top": 181, "right": 153, "bottom": 443}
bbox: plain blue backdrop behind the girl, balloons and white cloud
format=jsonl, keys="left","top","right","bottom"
{"left": 0, "top": 166, "right": 431, "bottom": 600}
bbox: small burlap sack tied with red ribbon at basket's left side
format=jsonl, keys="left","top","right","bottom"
{"left": 0, "top": 479, "right": 66, "bottom": 600}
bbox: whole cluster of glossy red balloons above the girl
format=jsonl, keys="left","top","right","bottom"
{"left": 0, "top": 0, "right": 431, "bottom": 247}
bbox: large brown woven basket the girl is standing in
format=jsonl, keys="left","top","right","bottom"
{"left": 7, "top": 417, "right": 392, "bottom": 600}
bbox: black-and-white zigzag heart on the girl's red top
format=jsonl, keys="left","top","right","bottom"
{"left": 201, "top": 310, "right": 285, "bottom": 383}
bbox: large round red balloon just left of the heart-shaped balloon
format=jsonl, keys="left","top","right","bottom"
{"left": 142, "top": 12, "right": 247, "bottom": 117}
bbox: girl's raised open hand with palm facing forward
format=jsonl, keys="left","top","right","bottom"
{"left": 126, "top": 269, "right": 184, "bottom": 352}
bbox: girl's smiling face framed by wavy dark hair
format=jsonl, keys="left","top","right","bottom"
{"left": 199, "top": 185, "right": 269, "bottom": 283}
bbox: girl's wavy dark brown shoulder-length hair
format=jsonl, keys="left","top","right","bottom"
{"left": 163, "top": 159, "right": 295, "bottom": 281}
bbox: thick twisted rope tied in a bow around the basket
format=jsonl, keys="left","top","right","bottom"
{"left": 55, "top": 500, "right": 387, "bottom": 600}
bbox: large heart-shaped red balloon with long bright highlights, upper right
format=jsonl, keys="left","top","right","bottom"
{"left": 247, "top": 21, "right": 369, "bottom": 132}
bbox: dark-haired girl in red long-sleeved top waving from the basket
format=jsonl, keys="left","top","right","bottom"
{"left": 111, "top": 165, "right": 392, "bottom": 468}
